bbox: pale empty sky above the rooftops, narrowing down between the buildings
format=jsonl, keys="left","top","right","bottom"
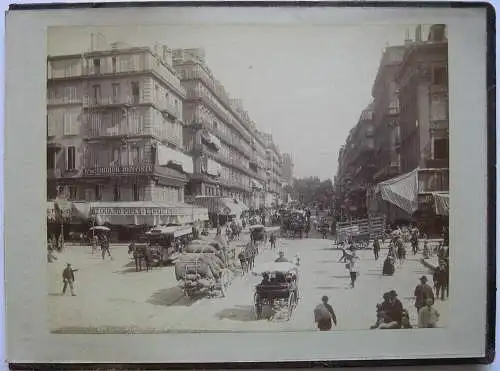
{"left": 47, "top": 25, "right": 426, "bottom": 179}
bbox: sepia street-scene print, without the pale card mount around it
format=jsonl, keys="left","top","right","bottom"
{"left": 44, "top": 23, "right": 453, "bottom": 336}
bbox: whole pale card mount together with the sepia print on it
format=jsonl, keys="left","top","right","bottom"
{"left": 6, "top": 3, "right": 487, "bottom": 363}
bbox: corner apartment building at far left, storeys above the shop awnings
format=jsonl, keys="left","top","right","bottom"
{"left": 47, "top": 44, "right": 193, "bottom": 212}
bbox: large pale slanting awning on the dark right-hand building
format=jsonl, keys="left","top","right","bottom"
{"left": 377, "top": 169, "right": 418, "bottom": 215}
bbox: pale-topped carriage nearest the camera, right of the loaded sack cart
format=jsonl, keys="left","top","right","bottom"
{"left": 254, "top": 262, "right": 299, "bottom": 321}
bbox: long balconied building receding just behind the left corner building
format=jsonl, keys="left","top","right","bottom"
{"left": 173, "top": 49, "right": 266, "bottom": 208}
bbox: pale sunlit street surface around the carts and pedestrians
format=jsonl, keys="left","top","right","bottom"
{"left": 49, "top": 235, "right": 448, "bottom": 333}
